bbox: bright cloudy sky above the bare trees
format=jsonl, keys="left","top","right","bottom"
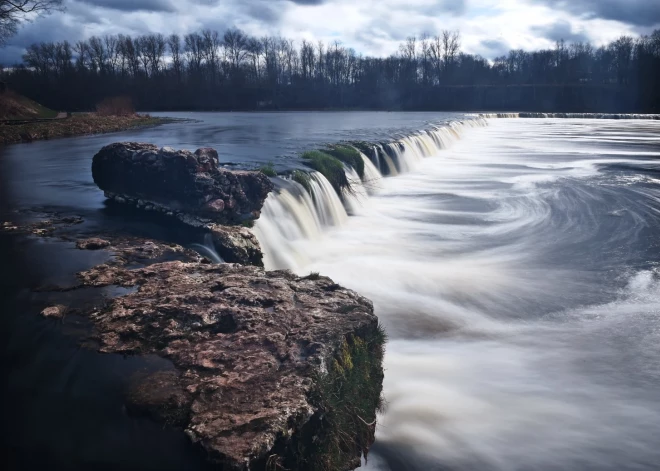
{"left": 0, "top": 0, "right": 660, "bottom": 65}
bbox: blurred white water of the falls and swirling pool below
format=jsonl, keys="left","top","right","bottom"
{"left": 256, "top": 118, "right": 660, "bottom": 470}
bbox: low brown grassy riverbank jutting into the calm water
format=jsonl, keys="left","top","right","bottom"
{"left": 0, "top": 113, "right": 171, "bottom": 144}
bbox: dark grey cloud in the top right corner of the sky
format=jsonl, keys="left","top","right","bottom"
{"left": 534, "top": 0, "right": 660, "bottom": 26}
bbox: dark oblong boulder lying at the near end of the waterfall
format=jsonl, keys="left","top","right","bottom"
{"left": 92, "top": 142, "right": 273, "bottom": 226}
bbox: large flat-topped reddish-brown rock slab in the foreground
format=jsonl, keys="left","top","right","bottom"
{"left": 79, "top": 261, "right": 384, "bottom": 471}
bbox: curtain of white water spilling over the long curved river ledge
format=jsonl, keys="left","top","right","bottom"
{"left": 254, "top": 116, "right": 487, "bottom": 271}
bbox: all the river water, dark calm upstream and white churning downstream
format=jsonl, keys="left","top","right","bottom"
{"left": 0, "top": 113, "right": 660, "bottom": 471}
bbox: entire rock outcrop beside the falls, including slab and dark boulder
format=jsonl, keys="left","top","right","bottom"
{"left": 0, "top": 144, "right": 385, "bottom": 471}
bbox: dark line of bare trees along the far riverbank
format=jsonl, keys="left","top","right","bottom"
{"left": 2, "top": 29, "right": 660, "bottom": 112}
